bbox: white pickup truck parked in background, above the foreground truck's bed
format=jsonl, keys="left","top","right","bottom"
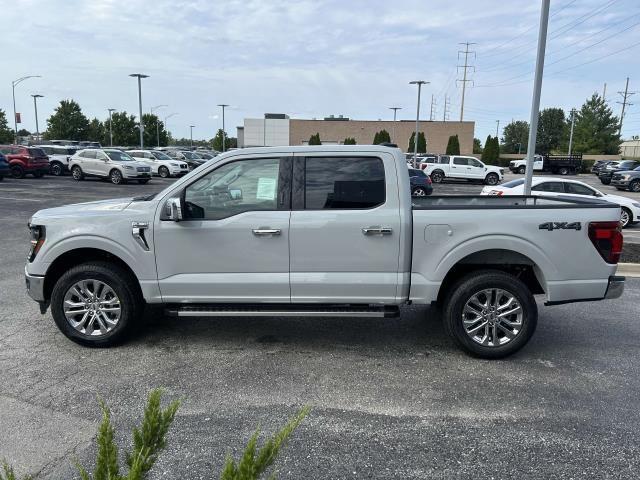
{"left": 424, "top": 155, "right": 504, "bottom": 185}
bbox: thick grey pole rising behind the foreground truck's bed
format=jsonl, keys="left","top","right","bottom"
{"left": 524, "top": 0, "right": 551, "bottom": 195}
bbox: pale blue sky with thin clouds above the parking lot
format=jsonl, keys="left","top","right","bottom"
{"left": 0, "top": 0, "right": 640, "bottom": 146}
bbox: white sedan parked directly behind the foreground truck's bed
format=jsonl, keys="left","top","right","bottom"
{"left": 481, "top": 177, "right": 640, "bottom": 228}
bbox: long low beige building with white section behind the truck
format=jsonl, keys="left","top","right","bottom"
{"left": 238, "top": 114, "right": 475, "bottom": 155}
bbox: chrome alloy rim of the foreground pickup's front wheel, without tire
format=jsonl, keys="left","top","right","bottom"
{"left": 63, "top": 279, "right": 121, "bottom": 336}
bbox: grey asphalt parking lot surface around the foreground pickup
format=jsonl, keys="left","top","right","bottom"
{"left": 0, "top": 175, "right": 640, "bottom": 479}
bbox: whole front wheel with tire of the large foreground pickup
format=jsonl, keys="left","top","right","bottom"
{"left": 51, "top": 261, "right": 143, "bottom": 347}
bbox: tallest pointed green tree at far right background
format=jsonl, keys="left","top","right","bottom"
{"left": 573, "top": 93, "right": 620, "bottom": 155}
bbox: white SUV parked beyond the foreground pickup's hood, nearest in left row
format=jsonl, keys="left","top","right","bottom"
{"left": 69, "top": 148, "right": 151, "bottom": 185}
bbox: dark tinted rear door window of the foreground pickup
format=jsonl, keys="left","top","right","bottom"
{"left": 304, "top": 157, "right": 385, "bottom": 210}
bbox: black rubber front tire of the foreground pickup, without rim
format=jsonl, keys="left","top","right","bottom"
{"left": 51, "top": 261, "right": 144, "bottom": 347}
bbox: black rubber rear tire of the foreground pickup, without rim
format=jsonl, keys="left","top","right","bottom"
{"left": 443, "top": 270, "right": 538, "bottom": 359}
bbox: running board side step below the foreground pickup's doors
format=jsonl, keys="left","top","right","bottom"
{"left": 165, "top": 304, "right": 400, "bottom": 318}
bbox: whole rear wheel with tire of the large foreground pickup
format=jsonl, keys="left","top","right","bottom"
{"left": 444, "top": 270, "right": 538, "bottom": 359}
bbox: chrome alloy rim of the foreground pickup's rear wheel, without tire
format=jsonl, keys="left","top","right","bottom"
{"left": 462, "top": 288, "right": 523, "bottom": 347}
